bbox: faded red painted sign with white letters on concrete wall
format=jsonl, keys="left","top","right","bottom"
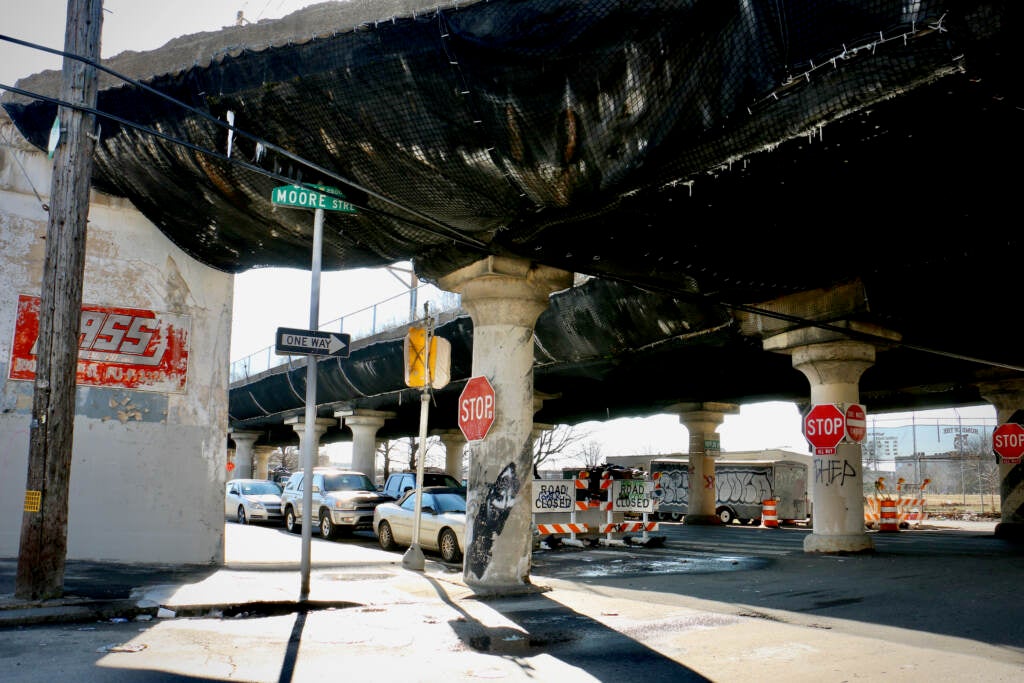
{"left": 8, "top": 294, "right": 190, "bottom": 393}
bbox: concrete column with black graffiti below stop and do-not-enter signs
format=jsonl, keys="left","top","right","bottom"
{"left": 764, "top": 323, "right": 898, "bottom": 553}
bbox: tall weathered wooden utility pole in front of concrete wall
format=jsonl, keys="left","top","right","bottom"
{"left": 14, "top": 0, "right": 103, "bottom": 600}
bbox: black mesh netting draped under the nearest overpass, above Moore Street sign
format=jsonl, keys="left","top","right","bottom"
{"left": 4, "top": 0, "right": 1019, "bottom": 300}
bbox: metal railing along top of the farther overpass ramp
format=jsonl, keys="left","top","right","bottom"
{"left": 228, "top": 285, "right": 462, "bottom": 384}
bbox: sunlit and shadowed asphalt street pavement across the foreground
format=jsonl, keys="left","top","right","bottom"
{"left": 0, "top": 522, "right": 1024, "bottom": 683}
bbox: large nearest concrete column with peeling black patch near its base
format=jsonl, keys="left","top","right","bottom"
{"left": 438, "top": 256, "right": 572, "bottom": 594}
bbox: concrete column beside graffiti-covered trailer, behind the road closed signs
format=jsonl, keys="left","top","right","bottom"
{"left": 671, "top": 402, "right": 739, "bottom": 524}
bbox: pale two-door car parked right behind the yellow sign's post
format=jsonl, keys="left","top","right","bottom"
{"left": 374, "top": 486, "right": 466, "bottom": 562}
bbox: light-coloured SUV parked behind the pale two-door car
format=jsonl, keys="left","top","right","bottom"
{"left": 281, "top": 467, "right": 394, "bottom": 539}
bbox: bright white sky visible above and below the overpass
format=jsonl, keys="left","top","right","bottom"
{"left": 0, "top": 0, "right": 995, "bottom": 459}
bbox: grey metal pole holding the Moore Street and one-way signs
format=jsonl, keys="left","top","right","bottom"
{"left": 299, "top": 209, "right": 324, "bottom": 602}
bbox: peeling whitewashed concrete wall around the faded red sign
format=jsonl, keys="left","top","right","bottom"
{"left": 0, "top": 114, "right": 233, "bottom": 564}
